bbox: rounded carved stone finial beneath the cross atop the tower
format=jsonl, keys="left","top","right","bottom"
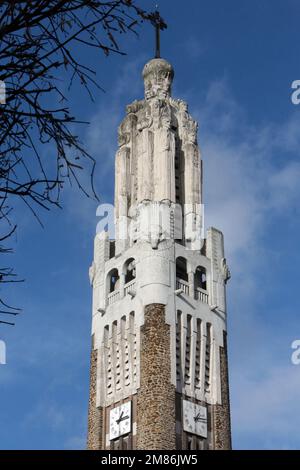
{"left": 143, "top": 58, "right": 174, "bottom": 100}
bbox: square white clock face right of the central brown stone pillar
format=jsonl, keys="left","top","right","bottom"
{"left": 183, "top": 400, "right": 207, "bottom": 437}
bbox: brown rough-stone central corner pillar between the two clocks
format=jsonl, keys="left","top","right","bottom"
{"left": 137, "top": 304, "right": 176, "bottom": 450}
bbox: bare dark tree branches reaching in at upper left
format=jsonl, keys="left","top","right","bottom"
{"left": 0, "top": 0, "right": 161, "bottom": 322}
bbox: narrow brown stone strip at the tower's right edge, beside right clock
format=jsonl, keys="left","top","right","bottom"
{"left": 213, "top": 331, "right": 231, "bottom": 450}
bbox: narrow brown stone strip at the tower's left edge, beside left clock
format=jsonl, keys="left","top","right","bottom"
{"left": 87, "top": 349, "right": 103, "bottom": 450}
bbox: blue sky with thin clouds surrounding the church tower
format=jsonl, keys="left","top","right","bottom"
{"left": 0, "top": 0, "right": 300, "bottom": 449}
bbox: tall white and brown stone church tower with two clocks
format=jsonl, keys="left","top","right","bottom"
{"left": 88, "top": 52, "right": 231, "bottom": 450}
